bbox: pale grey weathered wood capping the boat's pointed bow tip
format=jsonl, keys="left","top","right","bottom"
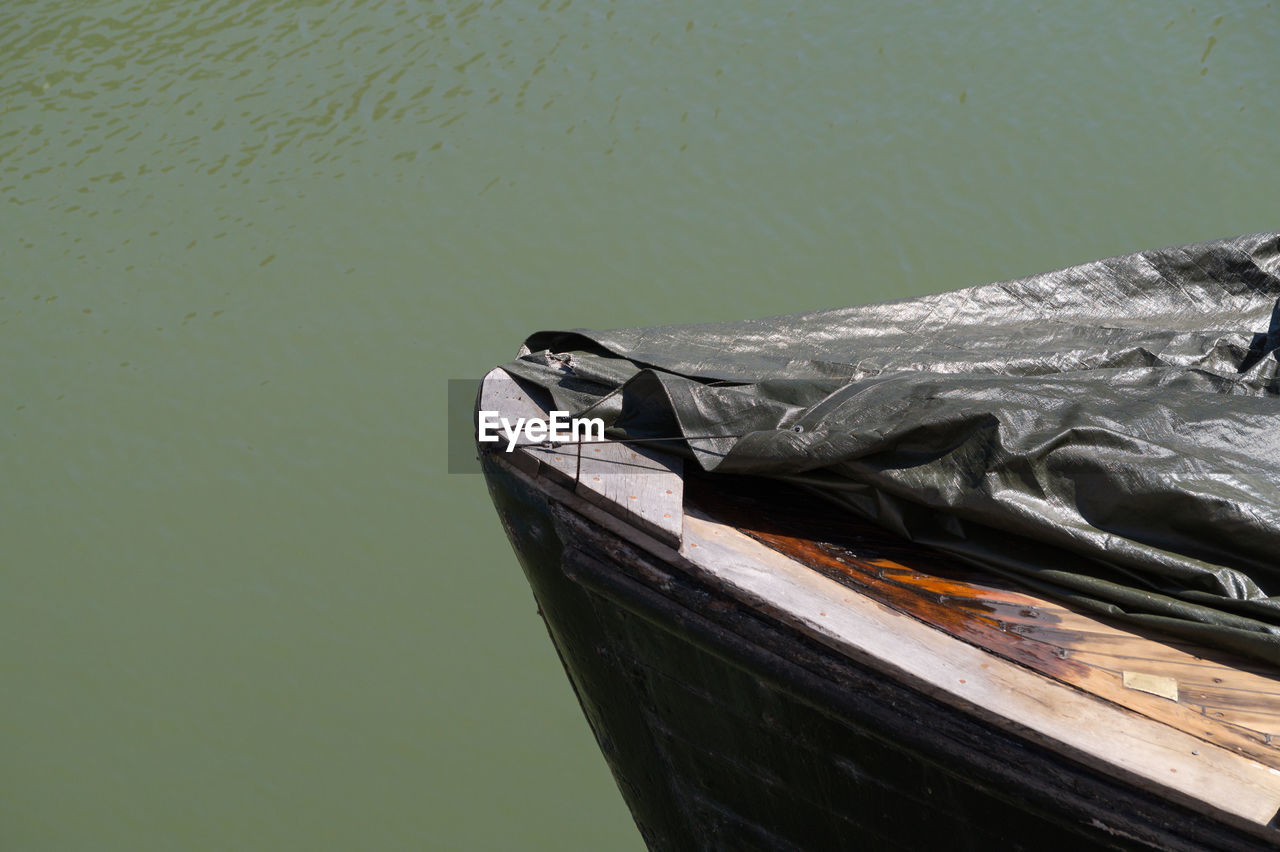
{"left": 479, "top": 368, "right": 685, "bottom": 545}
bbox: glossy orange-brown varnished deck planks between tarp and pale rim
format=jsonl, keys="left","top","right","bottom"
{"left": 694, "top": 478, "right": 1280, "bottom": 769}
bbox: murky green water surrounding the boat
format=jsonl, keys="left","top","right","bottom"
{"left": 0, "top": 0, "right": 1280, "bottom": 849}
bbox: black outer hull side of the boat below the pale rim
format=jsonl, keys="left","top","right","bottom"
{"left": 483, "top": 457, "right": 1272, "bottom": 849}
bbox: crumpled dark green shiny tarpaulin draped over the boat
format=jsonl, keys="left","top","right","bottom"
{"left": 506, "top": 233, "right": 1280, "bottom": 663}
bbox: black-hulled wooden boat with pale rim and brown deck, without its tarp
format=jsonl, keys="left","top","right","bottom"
{"left": 477, "top": 370, "right": 1280, "bottom": 849}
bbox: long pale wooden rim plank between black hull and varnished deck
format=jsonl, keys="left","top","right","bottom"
{"left": 680, "top": 504, "right": 1280, "bottom": 825}
